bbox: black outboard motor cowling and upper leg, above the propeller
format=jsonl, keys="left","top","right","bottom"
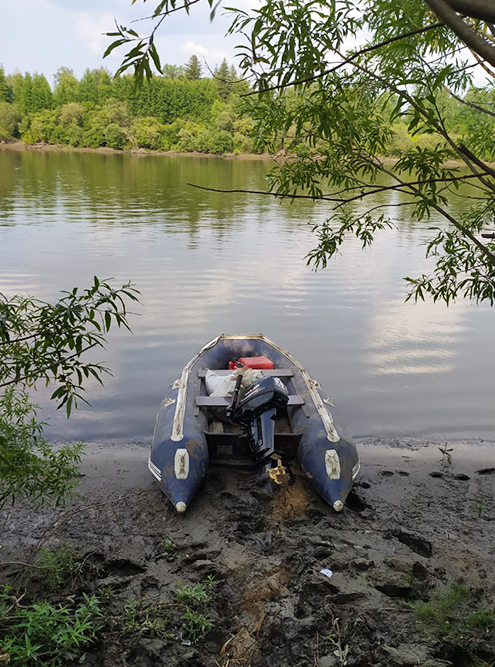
{"left": 232, "top": 377, "right": 289, "bottom": 462}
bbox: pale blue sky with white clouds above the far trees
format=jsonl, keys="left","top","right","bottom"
{"left": 0, "top": 0, "right": 249, "bottom": 85}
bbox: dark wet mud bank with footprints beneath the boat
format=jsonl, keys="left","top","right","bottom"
{"left": 0, "top": 439, "right": 495, "bottom": 667}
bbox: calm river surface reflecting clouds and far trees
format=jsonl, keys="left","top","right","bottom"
{"left": 0, "top": 150, "right": 495, "bottom": 441}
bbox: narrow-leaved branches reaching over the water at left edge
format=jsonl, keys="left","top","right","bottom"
{"left": 0, "top": 276, "right": 137, "bottom": 416}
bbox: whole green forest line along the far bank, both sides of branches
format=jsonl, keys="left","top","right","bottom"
{"left": 0, "top": 56, "right": 495, "bottom": 159}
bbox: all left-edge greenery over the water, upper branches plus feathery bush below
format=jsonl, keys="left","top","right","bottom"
{"left": 0, "top": 277, "right": 137, "bottom": 506}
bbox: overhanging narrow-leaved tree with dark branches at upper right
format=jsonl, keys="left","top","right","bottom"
{"left": 108, "top": 0, "right": 495, "bottom": 304}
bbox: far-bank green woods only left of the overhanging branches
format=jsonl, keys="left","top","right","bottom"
{"left": 0, "top": 62, "right": 260, "bottom": 154}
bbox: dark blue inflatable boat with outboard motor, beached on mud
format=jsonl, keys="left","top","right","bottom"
{"left": 148, "top": 334, "right": 359, "bottom": 513}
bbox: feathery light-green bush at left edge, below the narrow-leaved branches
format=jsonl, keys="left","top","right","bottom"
{"left": 0, "top": 386, "right": 82, "bottom": 507}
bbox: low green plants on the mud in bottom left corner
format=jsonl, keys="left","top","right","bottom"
{"left": 0, "top": 587, "right": 101, "bottom": 667}
